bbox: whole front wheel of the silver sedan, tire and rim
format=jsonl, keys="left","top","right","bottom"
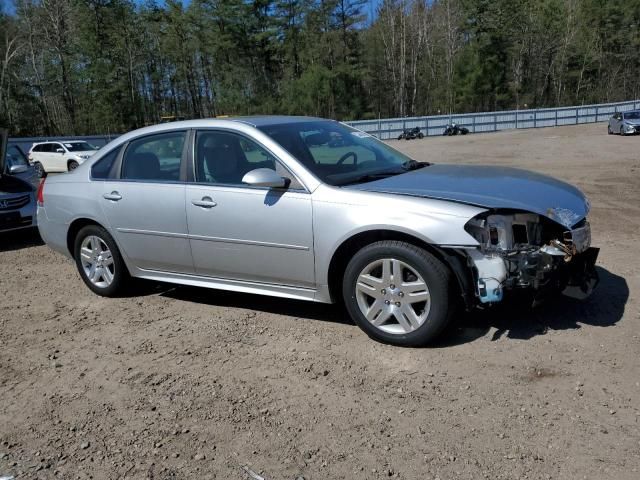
{"left": 342, "top": 241, "right": 452, "bottom": 347}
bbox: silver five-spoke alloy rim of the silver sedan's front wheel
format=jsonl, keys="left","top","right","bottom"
{"left": 355, "top": 258, "right": 431, "bottom": 335}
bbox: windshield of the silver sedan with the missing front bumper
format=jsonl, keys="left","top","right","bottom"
{"left": 259, "top": 120, "right": 427, "bottom": 185}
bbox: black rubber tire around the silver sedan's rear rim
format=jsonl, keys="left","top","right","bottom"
{"left": 73, "top": 225, "right": 130, "bottom": 297}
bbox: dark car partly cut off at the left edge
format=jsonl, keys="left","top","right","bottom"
{"left": 0, "top": 129, "right": 36, "bottom": 232}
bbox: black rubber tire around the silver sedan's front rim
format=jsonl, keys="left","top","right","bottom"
{"left": 342, "top": 240, "right": 454, "bottom": 347}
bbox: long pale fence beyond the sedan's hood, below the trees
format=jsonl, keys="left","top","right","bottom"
{"left": 345, "top": 100, "right": 640, "bottom": 140}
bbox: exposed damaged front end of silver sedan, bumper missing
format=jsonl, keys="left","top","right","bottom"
{"left": 465, "top": 211, "right": 599, "bottom": 303}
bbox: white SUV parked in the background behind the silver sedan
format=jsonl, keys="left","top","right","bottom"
{"left": 29, "top": 140, "right": 98, "bottom": 177}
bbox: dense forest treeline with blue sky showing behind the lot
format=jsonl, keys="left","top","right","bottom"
{"left": 0, "top": 0, "right": 640, "bottom": 135}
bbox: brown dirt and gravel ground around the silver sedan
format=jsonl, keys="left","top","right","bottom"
{"left": 0, "top": 124, "right": 640, "bottom": 480}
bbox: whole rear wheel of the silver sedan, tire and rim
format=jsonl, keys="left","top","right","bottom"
{"left": 74, "top": 225, "right": 129, "bottom": 297}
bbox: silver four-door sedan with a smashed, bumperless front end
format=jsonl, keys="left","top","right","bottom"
{"left": 38, "top": 116, "right": 598, "bottom": 345}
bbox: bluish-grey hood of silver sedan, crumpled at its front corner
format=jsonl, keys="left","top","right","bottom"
{"left": 347, "top": 165, "right": 589, "bottom": 228}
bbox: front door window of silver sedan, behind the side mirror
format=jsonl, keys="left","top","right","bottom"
{"left": 195, "top": 130, "right": 302, "bottom": 188}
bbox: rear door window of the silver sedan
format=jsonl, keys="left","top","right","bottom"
{"left": 120, "top": 132, "right": 186, "bottom": 182}
